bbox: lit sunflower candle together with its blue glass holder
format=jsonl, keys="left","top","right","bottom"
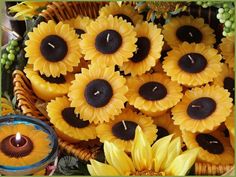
{"left": 0, "top": 115, "right": 57, "bottom": 175}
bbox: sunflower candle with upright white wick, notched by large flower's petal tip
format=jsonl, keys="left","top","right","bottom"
{"left": 96, "top": 109, "right": 157, "bottom": 152}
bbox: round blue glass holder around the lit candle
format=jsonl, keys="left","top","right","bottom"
{"left": 0, "top": 115, "right": 58, "bottom": 176}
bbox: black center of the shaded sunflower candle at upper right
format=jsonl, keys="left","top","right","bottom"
{"left": 176, "top": 25, "right": 202, "bottom": 43}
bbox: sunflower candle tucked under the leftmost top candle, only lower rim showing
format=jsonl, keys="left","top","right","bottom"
{"left": 24, "top": 66, "right": 74, "bottom": 101}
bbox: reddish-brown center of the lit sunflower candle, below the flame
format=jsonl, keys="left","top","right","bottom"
{"left": 0, "top": 135, "right": 34, "bottom": 158}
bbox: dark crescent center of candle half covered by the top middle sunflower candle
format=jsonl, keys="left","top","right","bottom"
{"left": 130, "top": 37, "right": 151, "bottom": 63}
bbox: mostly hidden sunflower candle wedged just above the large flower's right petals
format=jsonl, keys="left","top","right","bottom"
{"left": 153, "top": 113, "right": 182, "bottom": 140}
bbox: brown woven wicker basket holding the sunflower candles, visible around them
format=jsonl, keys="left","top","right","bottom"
{"left": 13, "top": 2, "right": 233, "bottom": 175}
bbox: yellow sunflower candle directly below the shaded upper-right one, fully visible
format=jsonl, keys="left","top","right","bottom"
{"left": 162, "top": 42, "right": 222, "bottom": 87}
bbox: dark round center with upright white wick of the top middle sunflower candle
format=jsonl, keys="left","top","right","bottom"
{"left": 95, "top": 30, "right": 122, "bottom": 54}
